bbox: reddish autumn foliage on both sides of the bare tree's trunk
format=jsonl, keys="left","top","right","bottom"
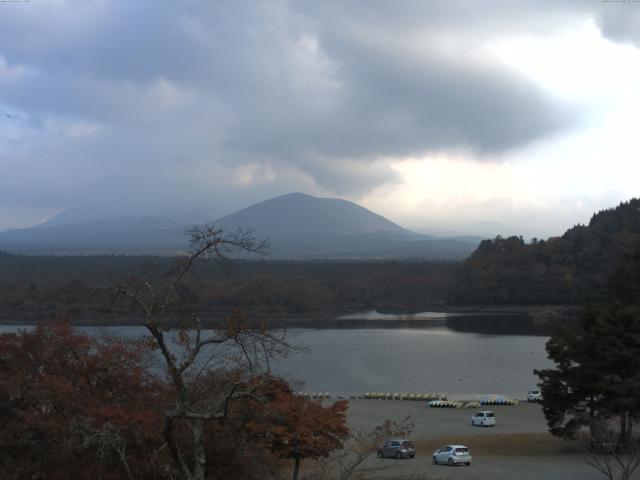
{"left": 0, "top": 323, "right": 348, "bottom": 480}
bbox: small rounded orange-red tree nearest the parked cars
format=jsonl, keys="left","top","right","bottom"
{"left": 248, "top": 385, "right": 349, "bottom": 480}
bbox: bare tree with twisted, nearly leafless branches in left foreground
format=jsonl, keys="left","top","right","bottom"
{"left": 110, "top": 227, "right": 298, "bottom": 480}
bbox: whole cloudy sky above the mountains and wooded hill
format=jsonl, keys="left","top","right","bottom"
{"left": 0, "top": 0, "right": 640, "bottom": 237}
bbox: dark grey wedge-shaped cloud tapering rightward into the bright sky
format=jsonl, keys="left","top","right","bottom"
{"left": 224, "top": 24, "right": 573, "bottom": 158}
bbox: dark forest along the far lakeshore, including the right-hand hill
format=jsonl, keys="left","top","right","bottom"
{"left": 0, "top": 199, "right": 640, "bottom": 323}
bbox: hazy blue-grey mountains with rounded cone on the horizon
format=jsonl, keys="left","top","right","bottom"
{"left": 0, "top": 193, "right": 477, "bottom": 259}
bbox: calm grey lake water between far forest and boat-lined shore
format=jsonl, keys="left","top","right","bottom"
{"left": 0, "top": 316, "right": 551, "bottom": 398}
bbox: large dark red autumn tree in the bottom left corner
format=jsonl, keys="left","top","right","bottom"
{"left": 0, "top": 323, "right": 166, "bottom": 480}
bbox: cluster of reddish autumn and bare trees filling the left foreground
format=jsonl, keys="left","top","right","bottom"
{"left": 0, "top": 228, "right": 411, "bottom": 480}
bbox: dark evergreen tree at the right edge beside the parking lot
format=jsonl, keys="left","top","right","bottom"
{"left": 536, "top": 250, "right": 640, "bottom": 448}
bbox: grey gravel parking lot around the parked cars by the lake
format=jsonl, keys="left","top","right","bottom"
{"left": 348, "top": 400, "right": 640, "bottom": 480}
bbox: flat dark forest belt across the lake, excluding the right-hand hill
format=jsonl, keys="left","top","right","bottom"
{"left": 0, "top": 253, "right": 456, "bottom": 323}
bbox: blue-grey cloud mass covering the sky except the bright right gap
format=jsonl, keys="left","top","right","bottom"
{"left": 0, "top": 0, "right": 632, "bottom": 219}
